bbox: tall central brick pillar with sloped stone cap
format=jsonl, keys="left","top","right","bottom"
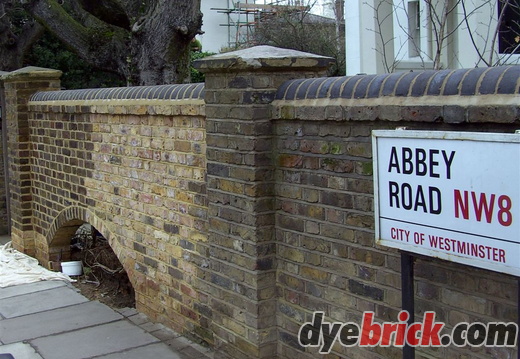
{"left": 196, "top": 46, "right": 332, "bottom": 359}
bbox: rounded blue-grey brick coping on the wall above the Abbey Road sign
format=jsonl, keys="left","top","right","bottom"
{"left": 276, "top": 66, "right": 520, "bottom": 100}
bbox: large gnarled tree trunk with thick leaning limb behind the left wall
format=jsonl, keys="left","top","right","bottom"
{"left": 0, "top": 0, "right": 202, "bottom": 85}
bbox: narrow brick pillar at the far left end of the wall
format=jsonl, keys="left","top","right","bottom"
{"left": 0, "top": 67, "right": 61, "bottom": 255}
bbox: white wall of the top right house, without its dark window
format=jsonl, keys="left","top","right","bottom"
{"left": 345, "top": 0, "right": 520, "bottom": 75}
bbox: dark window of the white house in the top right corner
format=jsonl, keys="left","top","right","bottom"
{"left": 498, "top": 0, "right": 520, "bottom": 54}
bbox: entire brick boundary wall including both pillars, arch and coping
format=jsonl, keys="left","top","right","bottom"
{"left": 1, "top": 56, "right": 520, "bottom": 359}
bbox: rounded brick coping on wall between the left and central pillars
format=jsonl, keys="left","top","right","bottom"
{"left": 31, "top": 83, "right": 204, "bottom": 102}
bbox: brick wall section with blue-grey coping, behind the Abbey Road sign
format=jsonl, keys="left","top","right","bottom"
{"left": 273, "top": 67, "right": 520, "bottom": 359}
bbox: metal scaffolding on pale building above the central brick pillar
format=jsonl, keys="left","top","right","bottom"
{"left": 211, "top": 0, "right": 309, "bottom": 49}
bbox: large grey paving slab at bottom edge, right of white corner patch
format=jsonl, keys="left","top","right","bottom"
{"left": 29, "top": 320, "right": 158, "bottom": 359}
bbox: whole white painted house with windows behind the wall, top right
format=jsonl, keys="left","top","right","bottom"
{"left": 345, "top": 0, "right": 520, "bottom": 75}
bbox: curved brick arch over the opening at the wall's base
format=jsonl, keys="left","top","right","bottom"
{"left": 45, "top": 206, "right": 135, "bottom": 287}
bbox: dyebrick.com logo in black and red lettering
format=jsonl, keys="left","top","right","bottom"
{"left": 298, "top": 310, "right": 518, "bottom": 354}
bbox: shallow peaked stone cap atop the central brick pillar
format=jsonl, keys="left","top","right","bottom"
{"left": 194, "top": 45, "right": 335, "bottom": 73}
